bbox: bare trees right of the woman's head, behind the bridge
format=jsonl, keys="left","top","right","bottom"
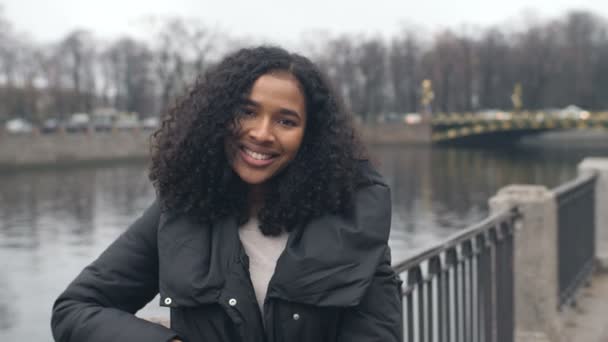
{"left": 318, "top": 11, "right": 608, "bottom": 119}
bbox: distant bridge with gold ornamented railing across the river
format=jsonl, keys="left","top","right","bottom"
{"left": 430, "top": 111, "right": 608, "bottom": 145}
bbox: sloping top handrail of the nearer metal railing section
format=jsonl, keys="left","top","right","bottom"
{"left": 393, "top": 206, "right": 519, "bottom": 274}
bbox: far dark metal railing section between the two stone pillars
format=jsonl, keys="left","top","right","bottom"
{"left": 553, "top": 174, "right": 597, "bottom": 309}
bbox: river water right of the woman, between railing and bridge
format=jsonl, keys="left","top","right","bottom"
{"left": 382, "top": 147, "right": 608, "bottom": 260}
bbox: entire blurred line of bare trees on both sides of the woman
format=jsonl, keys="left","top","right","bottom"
{"left": 0, "top": 11, "right": 608, "bottom": 122}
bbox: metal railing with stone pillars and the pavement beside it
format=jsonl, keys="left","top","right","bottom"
{"left": 393, "top": 158, "right": 608, "bottom": 342}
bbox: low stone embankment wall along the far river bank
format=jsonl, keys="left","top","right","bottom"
{"left": 0, "top": 124, "right": 430, "bottom": 166}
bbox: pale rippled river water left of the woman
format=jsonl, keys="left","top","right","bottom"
{"left": 0, "top": 165, "right": 154, "bottom": 341}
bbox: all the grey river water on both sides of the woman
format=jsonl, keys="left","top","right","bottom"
{"left": 0, "top": 135, "right": 608, "bottom": 342}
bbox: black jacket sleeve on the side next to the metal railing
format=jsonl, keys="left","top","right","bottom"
{"left": 338, "top": 247, "right": 403, "bottom": 342}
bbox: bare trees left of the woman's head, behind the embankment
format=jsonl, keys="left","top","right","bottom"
{"left": 0, "top": 14, "right": 226, "bottom": 121}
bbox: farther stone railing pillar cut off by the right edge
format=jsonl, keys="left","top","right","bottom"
{"left": 578, "top": 158, "right": 608, "bottom": 271}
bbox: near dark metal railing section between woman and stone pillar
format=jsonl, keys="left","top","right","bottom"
{"left": 394, "top": 209, "right": 519, "bottom": 342}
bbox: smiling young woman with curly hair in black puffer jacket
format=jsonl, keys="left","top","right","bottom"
{"left": 52, "top": 47, "right": 402, "bottom": 342}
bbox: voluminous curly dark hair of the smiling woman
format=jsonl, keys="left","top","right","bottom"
{"left": 149, "top": 46, "right": 365, "bottom": 235}
